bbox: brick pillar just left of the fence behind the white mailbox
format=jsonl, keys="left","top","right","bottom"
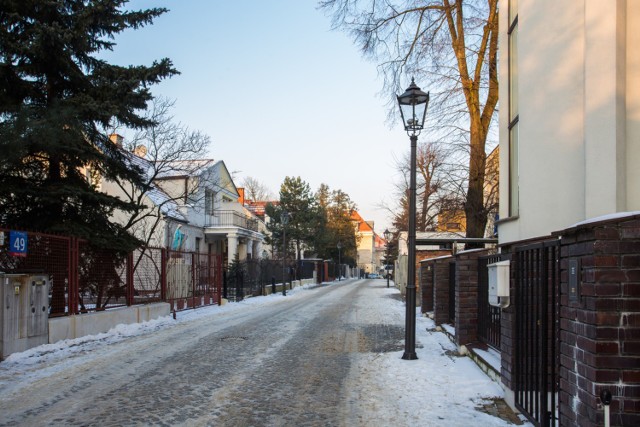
{"left": 455, "top": 250, "right": 489, "bottom": 346}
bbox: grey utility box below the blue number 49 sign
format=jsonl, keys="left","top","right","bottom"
{"left": 0, "top": 274, "right": 51, "bottom": 359}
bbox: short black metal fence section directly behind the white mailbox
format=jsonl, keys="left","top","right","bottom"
{"left": 478, "top": 255, "right": 502, "bottom": 351}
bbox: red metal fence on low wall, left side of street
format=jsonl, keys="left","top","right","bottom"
{"left": 0, "top": 228, "right": 222, "bottom": 317}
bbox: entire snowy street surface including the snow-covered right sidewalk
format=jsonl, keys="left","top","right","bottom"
{"left": 0, "top": 280, "right": 528, "bottom": 426}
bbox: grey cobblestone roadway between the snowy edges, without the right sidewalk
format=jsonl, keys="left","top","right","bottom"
{"left": 0, "top": 281, "right": 403, "bottom": 426}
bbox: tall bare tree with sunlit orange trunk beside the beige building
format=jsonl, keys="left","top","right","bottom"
{"left": 319, "top": 0, "right": 498, "bottom": 241}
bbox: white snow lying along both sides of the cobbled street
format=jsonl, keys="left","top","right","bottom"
{"left": 0, "top": 280, "right": 529, "bottom": 426}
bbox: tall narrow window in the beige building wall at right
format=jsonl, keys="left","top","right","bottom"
{"left": 508, "top": 0, "right": 520, "bottom": 216}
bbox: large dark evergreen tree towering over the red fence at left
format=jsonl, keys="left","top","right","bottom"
{"left": 0, "top": 0, "right": 177, "bottom": 250}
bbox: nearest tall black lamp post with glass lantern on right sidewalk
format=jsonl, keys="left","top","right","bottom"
{"left": 397, "top": 79, "right": 429, "bottom": 360}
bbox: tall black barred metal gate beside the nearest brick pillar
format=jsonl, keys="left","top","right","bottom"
{"left": 512, "top": 240, "right": 560, "bottom": 427}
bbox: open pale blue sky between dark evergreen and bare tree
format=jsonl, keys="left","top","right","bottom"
{"left": 103, "top": 0, "right": 410, "bottom": 234}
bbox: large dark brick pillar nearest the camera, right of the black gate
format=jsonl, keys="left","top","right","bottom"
{"left": 558, "top": 215, "right": 640, "bottom": 427}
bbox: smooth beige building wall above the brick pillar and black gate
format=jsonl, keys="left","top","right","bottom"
{"left": 499, "top": 0, "right": 640, "bottom": 243}
